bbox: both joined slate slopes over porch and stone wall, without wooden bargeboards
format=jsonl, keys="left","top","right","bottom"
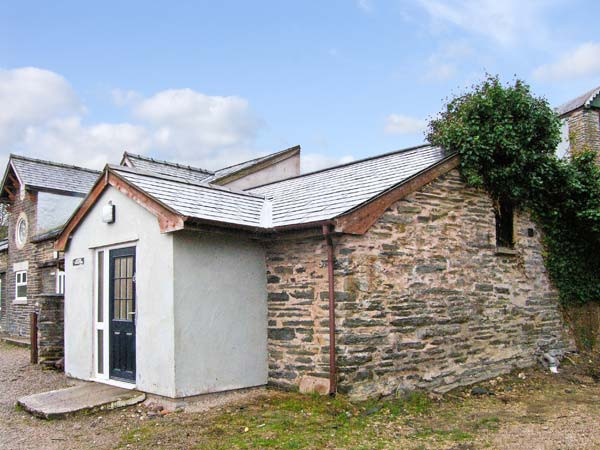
{"left": 109, "top": 146, "right": 449, "bottom": 230}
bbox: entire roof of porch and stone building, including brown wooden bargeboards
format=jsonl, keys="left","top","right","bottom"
{"left": 58, "top": 145, "right": 457, "bottom": 248}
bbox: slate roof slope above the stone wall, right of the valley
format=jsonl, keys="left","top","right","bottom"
{"left": 246, "top": 145, "right": 448, "bottom": 227}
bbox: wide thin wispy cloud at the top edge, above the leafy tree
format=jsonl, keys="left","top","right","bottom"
{"left": 419, "top": 0, "right": 549, "bottom": 46}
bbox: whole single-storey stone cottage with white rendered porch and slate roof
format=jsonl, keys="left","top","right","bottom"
{"left": 56, "top": 146, "right": 570, "bottom": 401}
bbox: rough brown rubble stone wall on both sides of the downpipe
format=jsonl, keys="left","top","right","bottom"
{"left": 267, "top": 170, "right": 571, "bottom": 397}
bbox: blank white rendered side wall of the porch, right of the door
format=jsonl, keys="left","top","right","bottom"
{"left": 174, "top": 231, "right": 267, "bottom": 397}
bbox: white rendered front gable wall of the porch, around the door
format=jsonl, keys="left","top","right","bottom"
{"left": 65, "top": 187, "right": 175, "bottom": 397}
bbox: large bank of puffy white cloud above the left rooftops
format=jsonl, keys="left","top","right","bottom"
{"left": 0, "top": 67, "right": 262, "bottom": 168}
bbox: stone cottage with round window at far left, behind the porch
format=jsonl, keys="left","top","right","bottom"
{"left": 0, "top": 155, "right": 100, "bottom": 364}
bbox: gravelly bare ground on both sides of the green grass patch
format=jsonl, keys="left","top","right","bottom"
{"left": 0, "top": 343, "right": 600, "bottom": 450}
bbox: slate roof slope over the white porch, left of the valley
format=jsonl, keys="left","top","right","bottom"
{"left": 110, "top": 166, "right": 266, "bottom": 227}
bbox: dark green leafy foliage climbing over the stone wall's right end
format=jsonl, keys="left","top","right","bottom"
{"left": 428, "top": 76, "right": 600, "bottom": 304}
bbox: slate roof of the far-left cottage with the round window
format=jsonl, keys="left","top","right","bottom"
{"left": 4, "top": 155, "right": 100, "bottom": 194}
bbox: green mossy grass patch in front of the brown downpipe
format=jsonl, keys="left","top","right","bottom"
{"left": 121, "top": 391, "right": 491, "bottom": 449}
